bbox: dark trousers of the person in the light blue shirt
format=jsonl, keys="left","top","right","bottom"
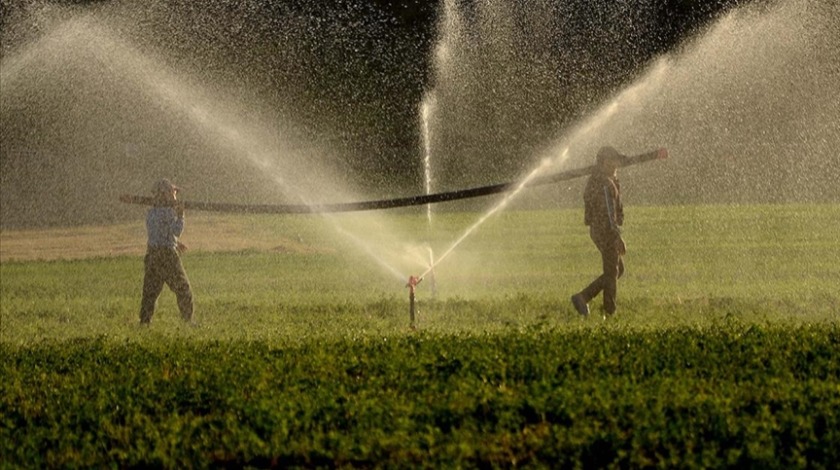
{"left": 140, "top": 247, "right": 193, "bottom": 323}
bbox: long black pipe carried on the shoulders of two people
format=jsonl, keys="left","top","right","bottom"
{"left": 120, "top": 149, "right": 667, "bottom": 214}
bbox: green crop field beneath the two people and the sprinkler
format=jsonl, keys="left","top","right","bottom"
{"left": 0, "top": 205, "right": 840, "bottom": 468}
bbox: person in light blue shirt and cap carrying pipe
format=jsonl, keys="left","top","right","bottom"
{"left": 140, "top": 179, "right": 193, "bottom": 325}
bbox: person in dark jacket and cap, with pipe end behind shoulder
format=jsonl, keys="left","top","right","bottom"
{"left": 571, "top": 147, "right": 668, "bottom": 319}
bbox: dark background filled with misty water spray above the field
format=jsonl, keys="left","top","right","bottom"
{"left": 0, "top": 0, "right": 840, "bottom": 229}
